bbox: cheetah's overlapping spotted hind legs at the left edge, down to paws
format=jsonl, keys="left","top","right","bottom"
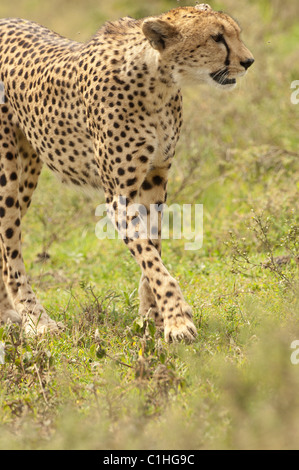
{"left": 0, "top": 124, "right": 61, "bottom": 335}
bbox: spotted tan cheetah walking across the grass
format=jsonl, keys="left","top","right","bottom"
{"left": 0, "top": 4, "right": 254, "bottom": 342}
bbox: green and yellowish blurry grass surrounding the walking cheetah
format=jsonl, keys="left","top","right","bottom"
{"left": 0, "top": 0, "right": 299, "bottom": 449}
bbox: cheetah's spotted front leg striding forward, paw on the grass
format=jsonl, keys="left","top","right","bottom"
{"left": 107, "top": 167, "right": 197, "bottom": 342}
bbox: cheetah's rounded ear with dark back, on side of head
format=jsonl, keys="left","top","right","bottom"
{"left": 142, "top": 18, "right": 178, "bottom": 51}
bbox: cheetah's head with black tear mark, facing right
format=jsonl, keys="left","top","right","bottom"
{"left": 142, "top": 4, "right": 254, "bottom": 89}
